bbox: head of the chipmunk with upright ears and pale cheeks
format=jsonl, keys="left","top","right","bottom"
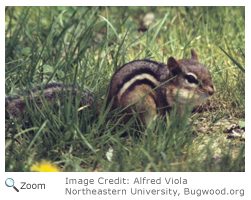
{"left": 167, "top": 49, "right": 216, "bottom": 106}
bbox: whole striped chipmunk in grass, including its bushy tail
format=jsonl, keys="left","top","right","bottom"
{"left": 5, "top": 50, "right": 216, "bottom": 123}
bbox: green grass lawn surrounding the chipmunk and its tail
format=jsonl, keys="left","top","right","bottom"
{"left": 5, "top": 7, "right": 245, "bottom": 171}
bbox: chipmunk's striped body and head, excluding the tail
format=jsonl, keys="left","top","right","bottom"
{"left": 106, "top": 49, "right": 216, "bottom": 124}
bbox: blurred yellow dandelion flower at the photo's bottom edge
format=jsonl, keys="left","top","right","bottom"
{"left": 30, "top": 160, "right": 60, "bottom": 172}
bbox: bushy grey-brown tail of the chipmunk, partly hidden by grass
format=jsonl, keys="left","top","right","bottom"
{"left": 5, "top": 82, "right": 94, "bottom": 118}
